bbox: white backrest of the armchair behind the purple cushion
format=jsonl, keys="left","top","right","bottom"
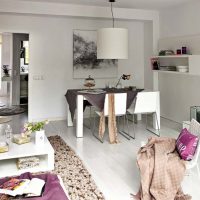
{"left": 189, "top": 119, "right": 200, "bottom": 163}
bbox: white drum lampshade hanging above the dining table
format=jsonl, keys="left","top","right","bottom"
{"left": 97, "top": 28, "right": 128, "bottom": 59}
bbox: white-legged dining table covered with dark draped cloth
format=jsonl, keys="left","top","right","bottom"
{"left": 65, "top": 88, "right": 160, "bottom": 138}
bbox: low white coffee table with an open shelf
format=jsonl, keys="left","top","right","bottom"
{"left": 0, "top": 137, "right": 54, "bottom": 178}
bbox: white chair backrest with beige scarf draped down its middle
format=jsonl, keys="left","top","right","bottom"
{"left": 104, "top": 93, "right": 127, "bottom": 116}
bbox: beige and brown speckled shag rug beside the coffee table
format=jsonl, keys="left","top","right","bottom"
{"left": 48, "top": 136, "right": 104, "bottom": 200}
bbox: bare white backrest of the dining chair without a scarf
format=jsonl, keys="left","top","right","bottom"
{"left": 134, "top": 91, "right": 160, "bottom": 114}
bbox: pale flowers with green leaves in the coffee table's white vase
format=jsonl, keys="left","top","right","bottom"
{"left": 21, "top": 120, "right": 49, "bottom": 137}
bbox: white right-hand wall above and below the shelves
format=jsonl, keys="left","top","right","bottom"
{"left": 159, "top": 1, "right": 200, "bottom": 122}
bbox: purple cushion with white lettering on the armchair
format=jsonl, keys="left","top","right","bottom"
{"left": 176, "top": 128, "right": 199, "bottom": 160}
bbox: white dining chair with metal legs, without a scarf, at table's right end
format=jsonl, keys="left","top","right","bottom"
{"left": 127, "top": 91, "right": 160, "bottom": 136}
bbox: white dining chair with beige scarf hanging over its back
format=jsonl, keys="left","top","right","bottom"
{"left": 93, "top": 93, "right": 130, "bottom": 143}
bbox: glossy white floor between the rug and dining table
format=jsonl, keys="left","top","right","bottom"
{"left": 1, "top": 115, "right": 200, "bottom": 200}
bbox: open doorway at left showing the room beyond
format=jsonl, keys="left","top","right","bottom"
{"left": 0, "top": 33, "right": 29, "bottom": 132}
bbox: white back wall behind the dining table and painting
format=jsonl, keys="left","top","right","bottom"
{"left": 0, "top": 14, "right": 144, "bottom": 120}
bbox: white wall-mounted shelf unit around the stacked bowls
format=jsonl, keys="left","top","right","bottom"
{"left": 152, "top": 55, "right": 200, "bottom": 75}
